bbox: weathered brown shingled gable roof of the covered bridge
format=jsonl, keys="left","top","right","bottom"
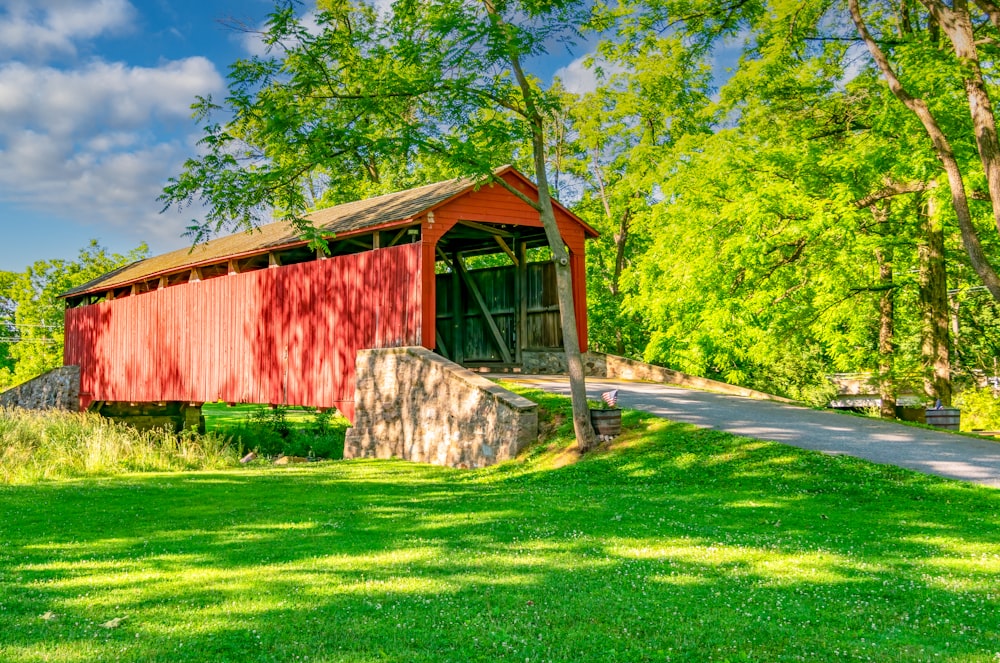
{"left": 59, "top": 166, "right": 597, "bottom": 298}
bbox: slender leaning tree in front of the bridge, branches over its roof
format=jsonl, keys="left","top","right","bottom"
{"left": 163, "top": 0, "right": 595, "bottom": 450}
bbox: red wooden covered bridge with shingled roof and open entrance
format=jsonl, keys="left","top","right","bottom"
{"left": 63, "top": 167, "right": 597, "bottom": 421}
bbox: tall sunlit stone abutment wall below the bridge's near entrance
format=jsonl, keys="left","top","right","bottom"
{"left": 344, "top": 347, "right": 538, "bottom": 468}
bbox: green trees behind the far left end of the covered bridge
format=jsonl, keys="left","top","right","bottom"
{"left": 0, "top": 240, "right": 149, "bottom": 386}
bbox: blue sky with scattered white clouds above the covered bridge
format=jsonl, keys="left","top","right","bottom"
{"left": 0, "top": 0, "right": 591, "bottom": 271}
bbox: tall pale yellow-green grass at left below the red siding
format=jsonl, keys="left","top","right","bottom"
{"left": 0, "top": 409, "right": 238, "bottom": 484}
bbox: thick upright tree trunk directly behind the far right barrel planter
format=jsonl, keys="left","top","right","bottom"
{"left": 917, "top": 198, "right": 951, "bottom": 405}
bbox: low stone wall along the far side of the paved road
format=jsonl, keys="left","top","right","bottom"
{"left": 524, "top": 351, "right": 792, "bottom": 403}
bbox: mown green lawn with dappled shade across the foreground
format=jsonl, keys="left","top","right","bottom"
{"left": 0, "top": 394, "right": 1000, "bottom": 663}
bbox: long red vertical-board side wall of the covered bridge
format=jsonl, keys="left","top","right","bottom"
{"left": 65, "top": 244, "right": 420, "bottom": 421}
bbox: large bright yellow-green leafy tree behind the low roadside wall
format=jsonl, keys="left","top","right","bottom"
{"left": 596, "top": 0, "right": 980, "bottom": 404}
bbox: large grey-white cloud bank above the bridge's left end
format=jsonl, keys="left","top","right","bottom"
{"left": 0, "top": 57, "right": 223, "bottom": 244}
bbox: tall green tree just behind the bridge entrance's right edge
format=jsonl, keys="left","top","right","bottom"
{"left": 567, "top": 35, "right": 714, "bottom": 356}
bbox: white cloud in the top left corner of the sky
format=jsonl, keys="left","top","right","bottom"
{"left": 0, "top": 0, "right": 136, "bottom": 59}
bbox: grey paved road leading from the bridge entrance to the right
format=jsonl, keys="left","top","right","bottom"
{"left": 494, "top": 375, "right": 1000, "bottom": 488}
